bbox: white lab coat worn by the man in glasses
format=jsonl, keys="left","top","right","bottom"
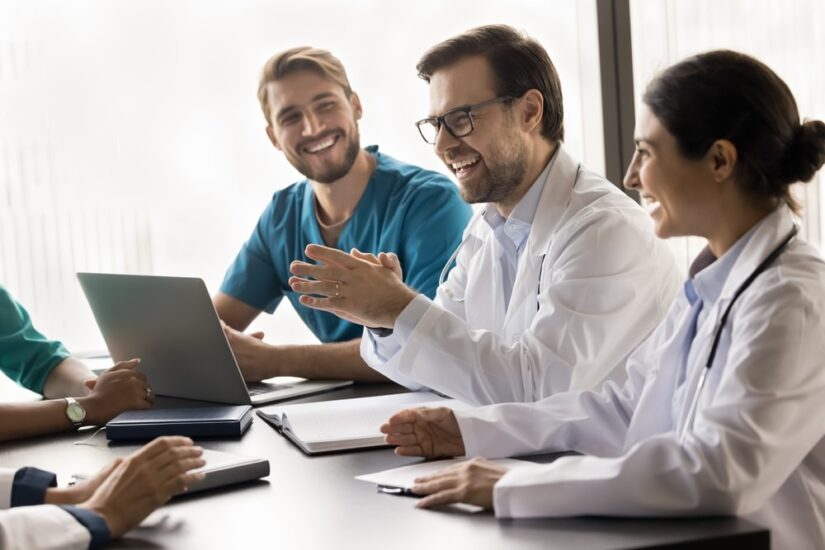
{"left": 361, "top": 146, "right": 681, "bottom": 404}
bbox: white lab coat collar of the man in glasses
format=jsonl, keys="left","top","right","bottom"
{"left": 527, "top": 143, "right": 580, "bottom": 256}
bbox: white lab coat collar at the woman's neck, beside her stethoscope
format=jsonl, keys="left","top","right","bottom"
{"left": 720, "top": 204, "right": 794, "bottom": 300}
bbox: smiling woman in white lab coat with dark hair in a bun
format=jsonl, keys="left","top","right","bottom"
{"left": 382, "top": 51, "right": 825, "bottom": 548}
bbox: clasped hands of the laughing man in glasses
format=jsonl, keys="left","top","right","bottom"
{"left": 289, "top": 244, "right": 416, "bottom": 328}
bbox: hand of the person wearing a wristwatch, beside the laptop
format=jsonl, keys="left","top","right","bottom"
{"left": 77, "top": 359, "right": 155, "bottom": 426}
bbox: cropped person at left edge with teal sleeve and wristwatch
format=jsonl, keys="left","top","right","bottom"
{"left": 0, "top": 286, "right": 153, "bottom": 441}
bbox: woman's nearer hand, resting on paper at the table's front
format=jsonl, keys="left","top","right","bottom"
{"left": 411, "top": 458, "right": 507, "bottom": 510}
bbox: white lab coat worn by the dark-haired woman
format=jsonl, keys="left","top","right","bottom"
{"left": 456, "top": 207, "right": 825, "bottom": 550}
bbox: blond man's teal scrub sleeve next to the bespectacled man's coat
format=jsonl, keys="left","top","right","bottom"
{"left": 400, "top": 179, "right": 472, "bottom": 299}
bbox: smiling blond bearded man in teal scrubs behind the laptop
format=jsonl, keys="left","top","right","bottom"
{"left": 215, "top": 47, "right": 471, "bottom": 381}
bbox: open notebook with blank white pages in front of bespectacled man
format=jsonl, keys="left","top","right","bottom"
{"left": 257, "top": 392, "right": 468, "bottom": 454}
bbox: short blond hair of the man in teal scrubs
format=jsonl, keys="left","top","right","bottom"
{"left": 258, "top": 46, "right": 352, "bottom": 122}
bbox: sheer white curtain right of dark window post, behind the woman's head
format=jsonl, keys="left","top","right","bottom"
{"left": 630, "top": 0, "right": 825, "bottom": 271}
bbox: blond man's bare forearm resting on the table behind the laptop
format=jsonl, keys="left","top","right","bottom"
{"left": 267, "top": 339, "right": 388, "bottom": 382}
